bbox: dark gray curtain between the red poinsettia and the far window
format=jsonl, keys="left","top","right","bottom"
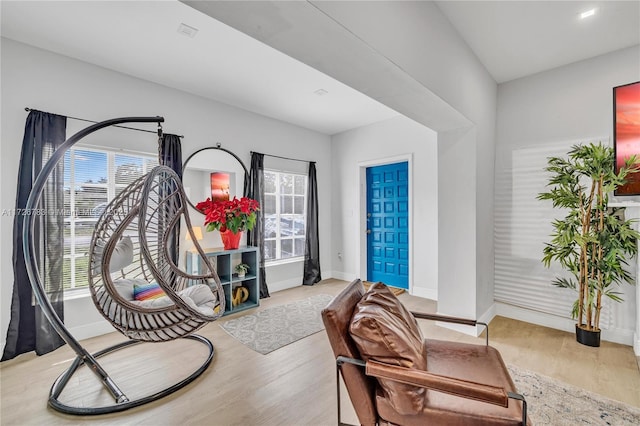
{"left": 247, "top": 152, "right": 269, "bottom": 299}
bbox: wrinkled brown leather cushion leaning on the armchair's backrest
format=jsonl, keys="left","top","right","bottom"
{"left": 349, "top": 283, "right": 427, "bottom": 415}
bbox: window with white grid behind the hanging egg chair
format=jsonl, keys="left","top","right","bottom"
{"left": 62, "top": 148, "right": 158, "bottom": 290}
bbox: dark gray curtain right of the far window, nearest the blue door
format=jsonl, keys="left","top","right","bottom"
{"left": 302, "top": 162, "right": 322, "bottom": 285}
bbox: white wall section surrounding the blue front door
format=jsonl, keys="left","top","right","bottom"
{"left": 331, "top": 116, "right": 438, "bottom": 298}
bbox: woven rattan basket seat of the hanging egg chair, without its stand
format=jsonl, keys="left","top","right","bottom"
{"left": 89, "top": 166, "right": 224, "bottom": 342}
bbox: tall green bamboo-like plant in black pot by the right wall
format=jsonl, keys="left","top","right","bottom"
{"left": 538, "top": 143, "right": 640, "bottom": 346}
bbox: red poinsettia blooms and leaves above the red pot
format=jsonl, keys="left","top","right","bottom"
{"left": 196, "top": 197, "right": 260, "bottom": 234}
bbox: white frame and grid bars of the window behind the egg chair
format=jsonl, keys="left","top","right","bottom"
{"left": 62, "top": 144, "right": 159, "bottom": 300}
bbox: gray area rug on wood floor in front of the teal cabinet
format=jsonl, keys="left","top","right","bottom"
{"left": 220, "top": 294, "right": 333, "bottom": 355}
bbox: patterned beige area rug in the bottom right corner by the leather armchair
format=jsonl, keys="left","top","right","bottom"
{"left": 509, "top": 366, "right": 640, "bottom": 426}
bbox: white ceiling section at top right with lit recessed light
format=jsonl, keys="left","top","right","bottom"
{"left": 437, "top": 1, "right": 640, "bottom": 83}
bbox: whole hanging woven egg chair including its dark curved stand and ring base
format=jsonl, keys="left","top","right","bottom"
{"left": 23, "top": 117, "right": 225, "bottom": 415}
